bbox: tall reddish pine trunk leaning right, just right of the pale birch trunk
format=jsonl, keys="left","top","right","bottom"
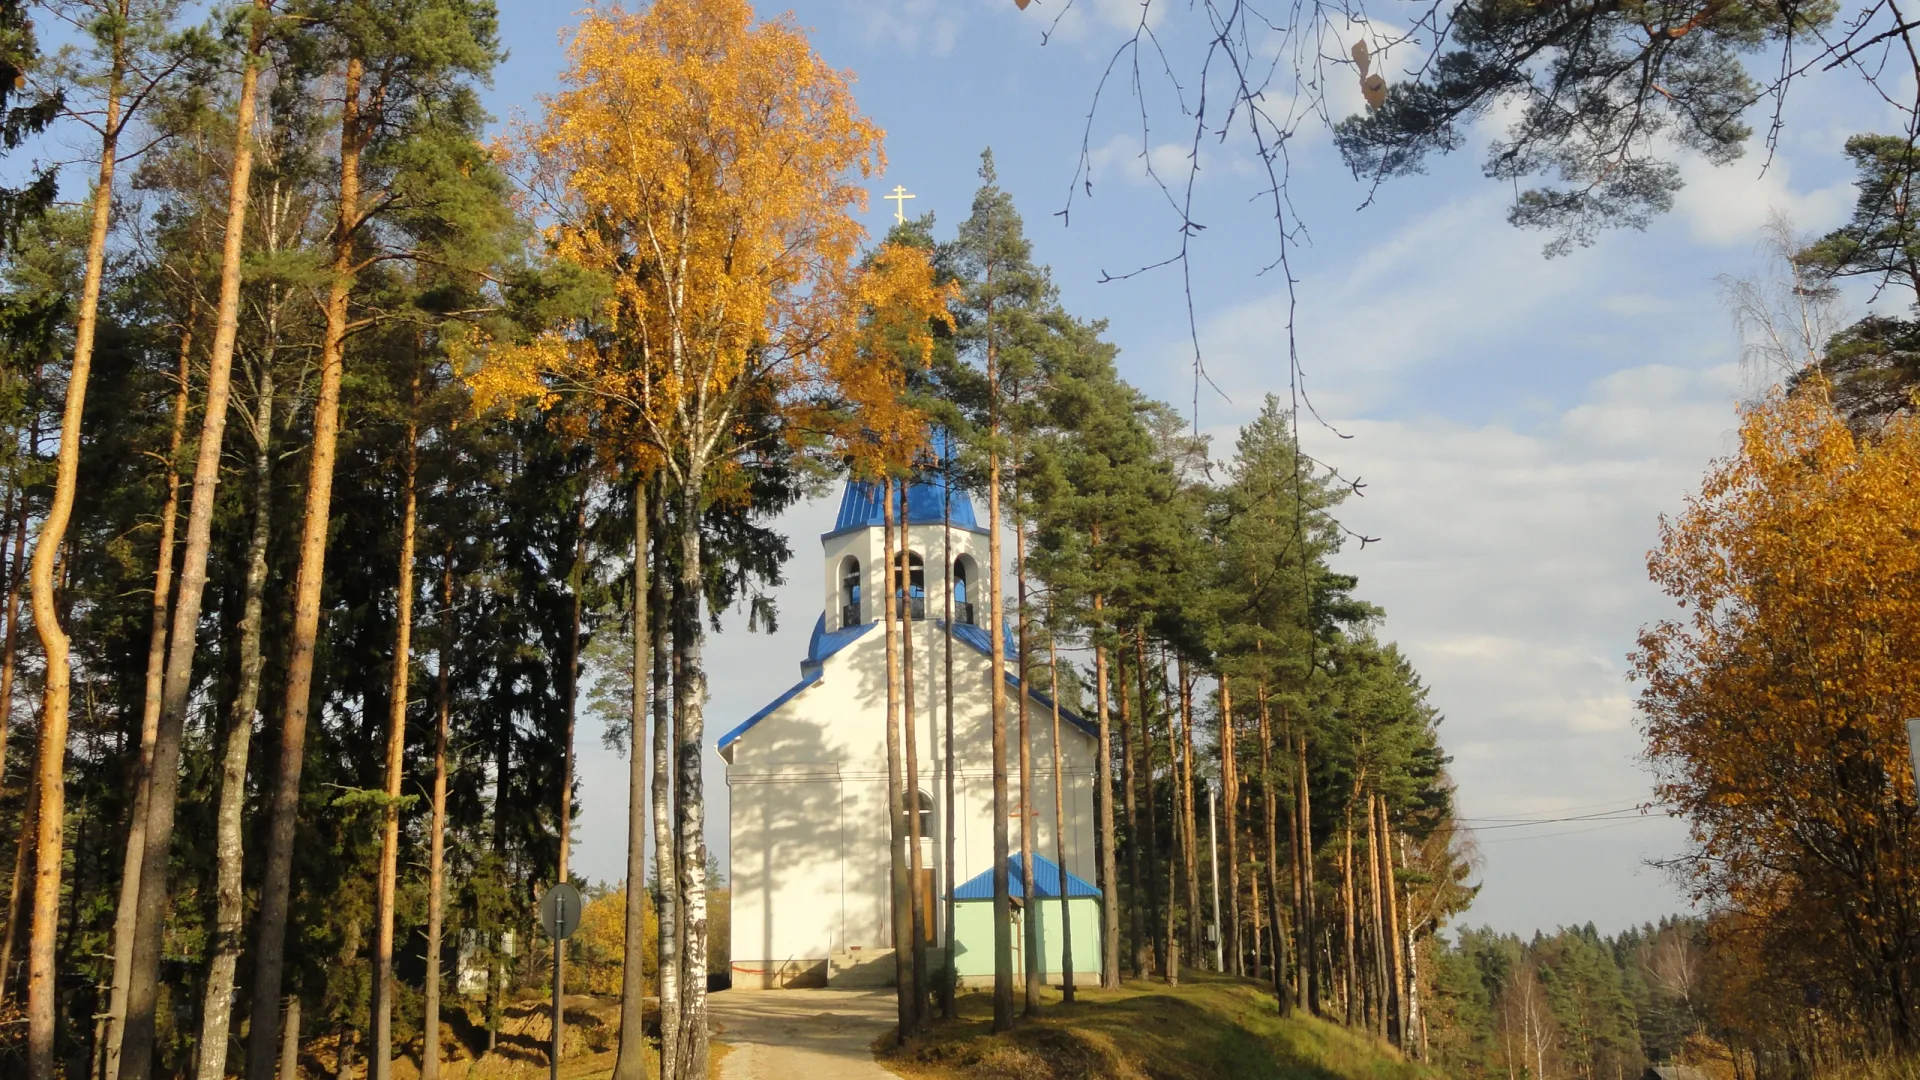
{"left": 248, "top": 56, "right": 365, "bottom": 1080}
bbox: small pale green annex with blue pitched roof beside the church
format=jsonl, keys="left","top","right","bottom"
{"left": 954, "top": 853, "right": 1100, "bottom": 986}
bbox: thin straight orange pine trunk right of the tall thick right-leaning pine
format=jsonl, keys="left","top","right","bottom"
{"left": 369, "top": 395, "right": 420, "bottom": 1080}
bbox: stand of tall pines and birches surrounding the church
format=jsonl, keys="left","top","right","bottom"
{"left": 0, "top": 0, "right": 1471, "bottom": 1080}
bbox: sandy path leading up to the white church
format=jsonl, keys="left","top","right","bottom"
{"left": 707, "top": 990, "right": 895, "bottom": 1080}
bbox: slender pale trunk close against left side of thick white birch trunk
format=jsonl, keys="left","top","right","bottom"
{"left": 647, "top": 479, "right": 680, "bottom": 1080}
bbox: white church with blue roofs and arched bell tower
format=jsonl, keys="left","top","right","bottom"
{"left": 720, "top": 477, "right": 1100, "bottom": 990}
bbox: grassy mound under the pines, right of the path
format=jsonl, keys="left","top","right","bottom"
{"left": 879, "top": 972, "right": 1440, "bottom": 1080}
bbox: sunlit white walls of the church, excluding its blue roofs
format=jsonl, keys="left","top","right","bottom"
{"left": 728, "top": 591, "right": 1094, "bottom": 988}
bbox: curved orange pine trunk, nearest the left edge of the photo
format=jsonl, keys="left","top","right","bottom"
{"left": 27, "top": 31, "right": 127, "bottom": 1080}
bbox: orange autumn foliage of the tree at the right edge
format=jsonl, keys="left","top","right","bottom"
{"left": 1632, "top": 384, "right": 1920, "bottom": 1045}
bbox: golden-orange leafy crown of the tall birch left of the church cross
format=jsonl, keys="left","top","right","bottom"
{"left": 468, "top": 0, "right": 945, "bottom": 472}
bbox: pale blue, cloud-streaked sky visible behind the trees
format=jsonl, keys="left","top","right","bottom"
{"left": 490, "top": 0, "right": 1891, "bottom": 932}
